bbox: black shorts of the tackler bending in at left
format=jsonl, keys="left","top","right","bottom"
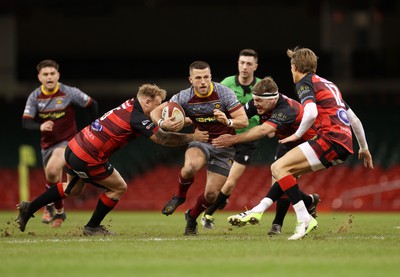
{"left": 65, "top": 146, "right": 114, "bottom": 184}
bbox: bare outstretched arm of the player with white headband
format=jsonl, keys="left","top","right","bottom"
{"left": 212, "top": 123, "right": 277, "bottom": 147}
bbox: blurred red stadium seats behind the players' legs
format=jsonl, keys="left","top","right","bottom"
{"left": 0, "top": 165, "right": 400, "bottom": 211}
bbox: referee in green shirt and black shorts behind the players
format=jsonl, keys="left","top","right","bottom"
{"left": 201, "top": 49, "right": 260, "bottom": 229}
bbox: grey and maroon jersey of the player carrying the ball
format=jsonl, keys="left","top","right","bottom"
{"left": 170, "top": 82, "right": 242, "bottom": 142}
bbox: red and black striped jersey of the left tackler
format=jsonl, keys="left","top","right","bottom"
{"left": 68, "top": 98, "right": 159, "bottom": 164}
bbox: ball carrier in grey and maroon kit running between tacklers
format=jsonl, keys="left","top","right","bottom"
{"left": 152, "top": 61, "right": 248, "bottom": 235}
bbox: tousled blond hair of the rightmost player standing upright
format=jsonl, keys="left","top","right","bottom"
{"left": 286, "top": 46, "right": 318, "bottom": 73}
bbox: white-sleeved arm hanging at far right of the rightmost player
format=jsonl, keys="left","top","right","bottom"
{"left": 347, "top": 108, "right": 374, "bottom": 169}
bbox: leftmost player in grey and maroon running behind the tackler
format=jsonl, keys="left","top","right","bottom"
{"left": 22, "top": 60, "right": 98, "bottom": 227}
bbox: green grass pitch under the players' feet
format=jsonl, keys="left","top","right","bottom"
{"left": 0, "top": 210, "right": 400, "bottom": 277}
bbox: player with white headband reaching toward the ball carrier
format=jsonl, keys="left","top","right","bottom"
{"left": 213, "top": 77, "right": 319, "bottom": 235}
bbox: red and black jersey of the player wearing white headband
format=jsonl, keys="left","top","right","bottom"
{"left": 245, "top": 93, "right": 317, "bottom": 147}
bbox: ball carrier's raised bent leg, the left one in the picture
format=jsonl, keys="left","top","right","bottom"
{"left": 161, "top": 144, "right": 208, "bottom": 216}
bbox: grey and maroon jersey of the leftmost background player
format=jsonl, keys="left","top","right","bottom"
{"left": 22, "top": 83, "right": 92, "bottom": 149}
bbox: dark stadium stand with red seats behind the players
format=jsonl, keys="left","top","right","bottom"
{"left": 0, "top": 0, "right": 400, "bottom": 211}
